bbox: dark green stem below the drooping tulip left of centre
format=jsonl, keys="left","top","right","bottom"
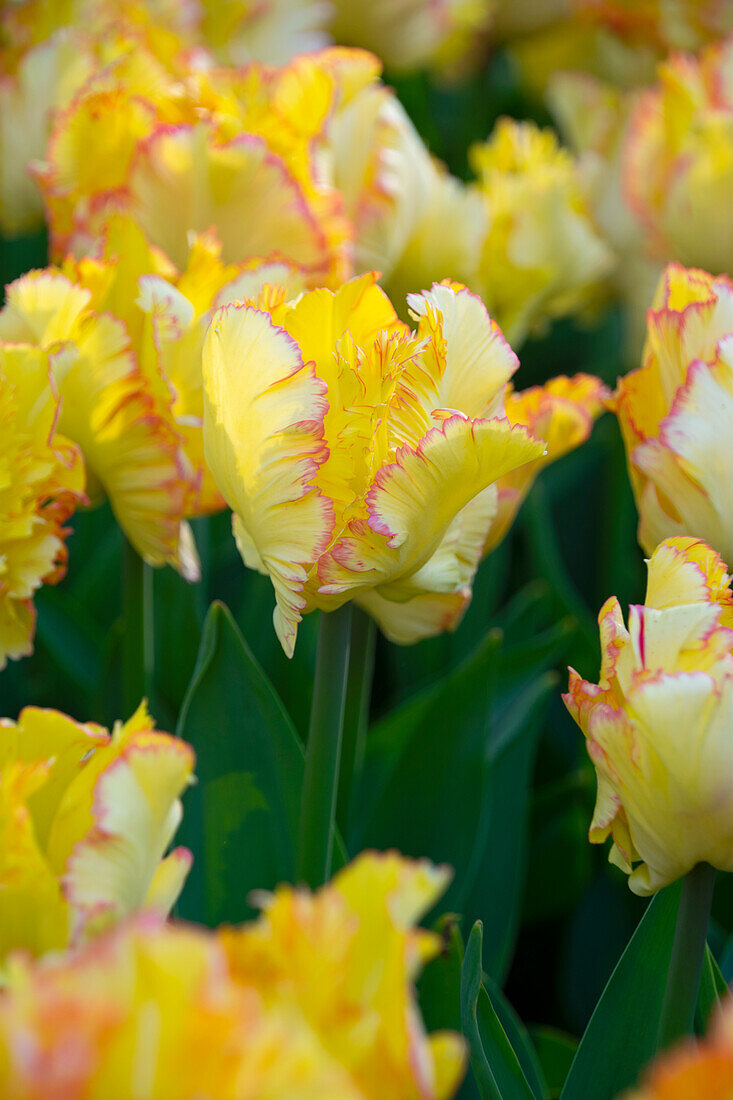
{"left": 122, "top": 541, "right": 154, "bottom": 718}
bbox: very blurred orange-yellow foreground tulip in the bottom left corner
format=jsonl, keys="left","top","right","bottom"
{"left": 0, "top": 916, "right": 360, "bottom": 1100}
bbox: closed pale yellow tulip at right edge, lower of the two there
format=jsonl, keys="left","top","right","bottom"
{"left": 564, "top": 538, "right": 733, "bottom": 894}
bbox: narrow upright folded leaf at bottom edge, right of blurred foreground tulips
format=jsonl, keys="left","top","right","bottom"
{"left": 461, "top": 921, "right": 534, "bottom": 1100}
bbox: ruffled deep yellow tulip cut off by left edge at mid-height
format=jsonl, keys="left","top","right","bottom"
{"left": 0, "top": 344, "right": 86, "bottom": 669}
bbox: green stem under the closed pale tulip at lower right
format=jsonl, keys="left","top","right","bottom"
{"left": 657, "top": 864, "right": 715, "bottom": 1051}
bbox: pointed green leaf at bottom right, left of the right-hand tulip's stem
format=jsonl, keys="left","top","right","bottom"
{"left": 561, "top": 882, "right": 681, "bottom": 1100}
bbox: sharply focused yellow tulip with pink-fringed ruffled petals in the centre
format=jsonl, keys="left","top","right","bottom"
{"left": 204, "top": 275, "right": 545, "bottom": 655}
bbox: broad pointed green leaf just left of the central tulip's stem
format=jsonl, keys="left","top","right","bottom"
{"left": 177, "top": 603, "right": 304, "bottom": 925}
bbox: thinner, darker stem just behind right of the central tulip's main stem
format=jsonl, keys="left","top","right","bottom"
{"left": 336, "top": 607, "right": 376, "bottom": 834}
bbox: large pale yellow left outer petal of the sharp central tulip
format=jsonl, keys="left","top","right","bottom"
{"left": 204, "top": 306, "right": 333, "bottom": 653}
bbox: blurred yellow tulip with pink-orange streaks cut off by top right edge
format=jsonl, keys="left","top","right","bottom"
{"left": 624, "top": 39, "right": 733, "bottom": 274}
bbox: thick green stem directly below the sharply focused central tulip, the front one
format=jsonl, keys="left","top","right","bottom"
{"left": 297, "top": 604, "right": 351, "bottom": 889}
